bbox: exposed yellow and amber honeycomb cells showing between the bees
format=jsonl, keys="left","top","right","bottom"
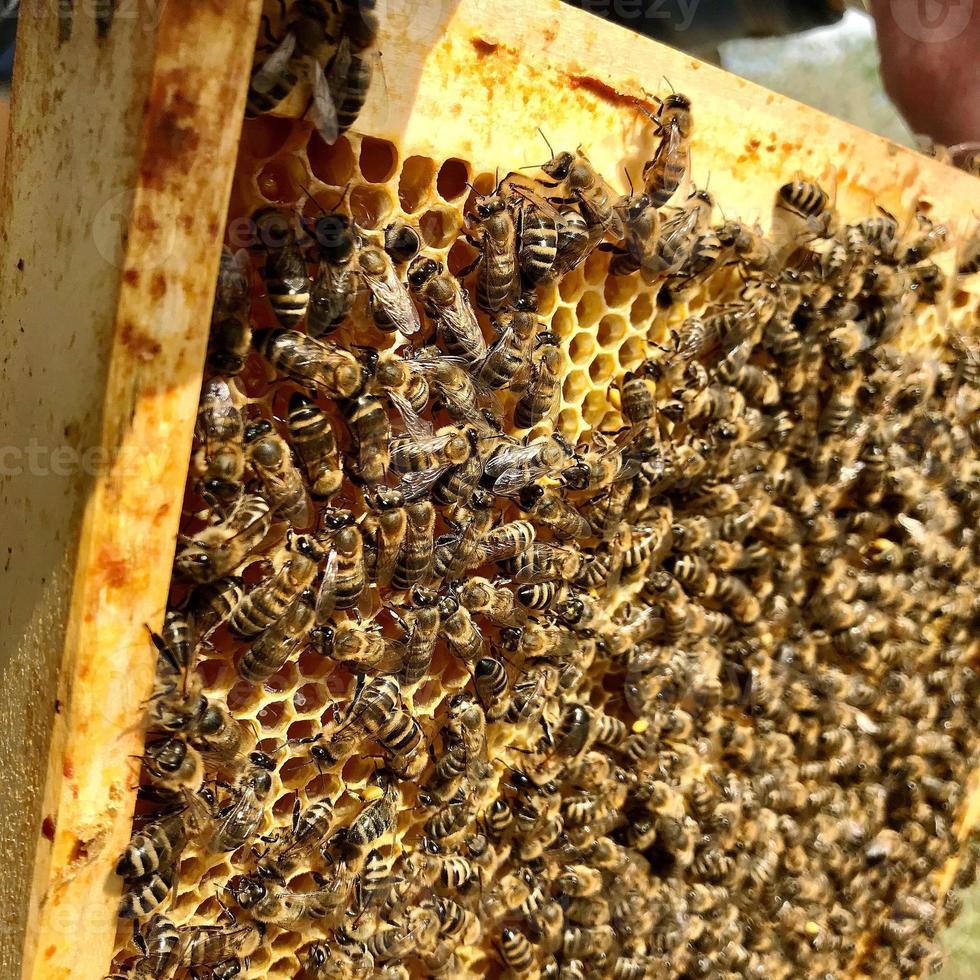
{"left": 107, "top": 7, "right": 977, "bottom": 978}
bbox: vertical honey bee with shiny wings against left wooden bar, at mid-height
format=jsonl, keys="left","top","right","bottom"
{"left": 192, "top": 378, "right": 245, "bottom": 501}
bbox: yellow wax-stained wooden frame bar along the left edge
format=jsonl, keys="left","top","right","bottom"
{"left": 0, "top": 0, "right": 259, "bottom": 978}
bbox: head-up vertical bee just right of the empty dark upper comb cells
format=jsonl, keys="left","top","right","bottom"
{"left": 460, "top": 185, "right": 521, "bottom": 310}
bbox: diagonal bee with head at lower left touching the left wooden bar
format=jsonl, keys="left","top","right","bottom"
{"left": 174, "top": 495, "right": 272, "bottom": 583}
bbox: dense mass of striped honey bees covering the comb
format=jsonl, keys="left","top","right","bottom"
{"left": 107, "top": 2, "right": 980, "bottom": 980}
